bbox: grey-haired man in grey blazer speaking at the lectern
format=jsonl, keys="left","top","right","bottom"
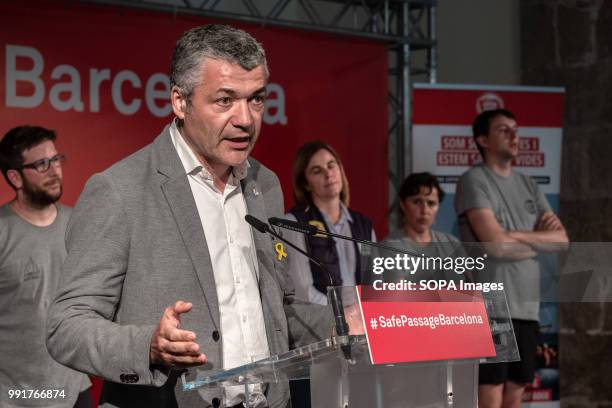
{"left": 47, "top": 25, "right": 340, "bottom": 408}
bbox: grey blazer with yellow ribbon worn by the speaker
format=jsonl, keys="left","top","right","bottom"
{"left": 47, "top": 127, "right": 333, "bottom": 408}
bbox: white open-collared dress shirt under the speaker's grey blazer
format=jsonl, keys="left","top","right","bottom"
{"left": 170, "top": 121, "right": 270, "bottom": 407}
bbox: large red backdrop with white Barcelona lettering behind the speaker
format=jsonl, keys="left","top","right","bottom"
{"left": 0, "top": 1, "right": 388, "bottom": 236}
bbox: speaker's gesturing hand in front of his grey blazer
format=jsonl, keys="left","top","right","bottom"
{"left": 149, "top": 300, "right": 206, "bottom": 367}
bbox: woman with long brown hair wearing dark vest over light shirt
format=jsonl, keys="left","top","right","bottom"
{"left": 285, "top": 141, "right": 376, "bottom": 304}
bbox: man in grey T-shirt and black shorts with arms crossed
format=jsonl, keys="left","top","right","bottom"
{"left": 455, "top": 109, "right": 568, "bottom": 408}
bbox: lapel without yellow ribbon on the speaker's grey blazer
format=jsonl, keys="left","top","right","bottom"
{"left": 155, "top": 128, "right": 221, "bottom": 328}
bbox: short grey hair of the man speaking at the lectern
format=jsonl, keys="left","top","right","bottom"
{"left": 170, "top": 24, "right": 268, "bottom": 103}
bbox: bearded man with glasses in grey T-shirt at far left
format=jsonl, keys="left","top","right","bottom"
{"left": 0, "top": 126, "right": 91, "bottom": 408}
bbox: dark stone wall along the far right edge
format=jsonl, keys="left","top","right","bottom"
{"left": 520, "top": 0, "right": 612, "bottom": 408}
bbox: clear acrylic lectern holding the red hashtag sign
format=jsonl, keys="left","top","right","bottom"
{"left": 182, "top": 287, "right": 519, "bottom": 408}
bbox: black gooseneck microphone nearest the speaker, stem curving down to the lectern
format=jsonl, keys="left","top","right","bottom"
{"left": 244, "top": 214, "right": 352, "bottom": 360}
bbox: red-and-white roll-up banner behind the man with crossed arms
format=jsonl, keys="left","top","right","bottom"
{"left": 412, "top": 84, "right": 565, "bottom": 408}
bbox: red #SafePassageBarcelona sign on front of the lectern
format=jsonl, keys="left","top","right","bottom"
{"left": 357, "top": 286, "right": 495, "bottom": 364}
